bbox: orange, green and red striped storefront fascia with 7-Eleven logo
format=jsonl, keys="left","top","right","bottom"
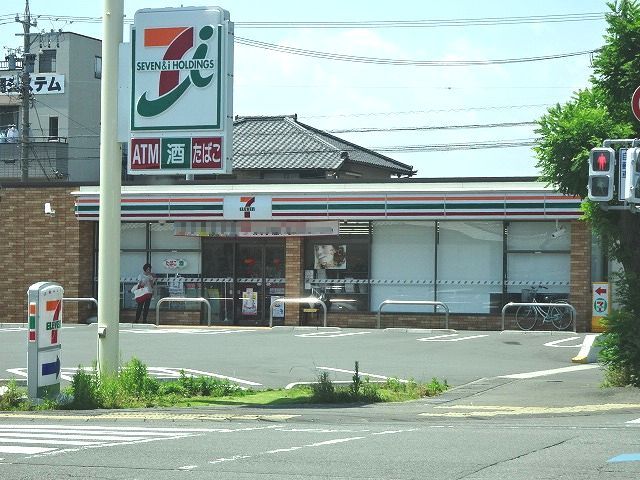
{"left": 73, "top": 182, "right": 581, "bottom": 222}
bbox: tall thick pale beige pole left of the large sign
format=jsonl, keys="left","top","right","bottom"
{"left": 98, "top": 0, "right": 124, "bottom": 375}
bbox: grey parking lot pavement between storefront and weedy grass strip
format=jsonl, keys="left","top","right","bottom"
{"left": 0, "top": 324, "right": 600, "bottom": 388}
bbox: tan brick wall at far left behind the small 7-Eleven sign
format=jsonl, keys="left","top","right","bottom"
{"left": 0, "top": 186, "right": 95, "bottom": 323}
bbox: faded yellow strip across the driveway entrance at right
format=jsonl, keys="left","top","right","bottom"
{"left": 418, "top": 403, "right": 640, "bottom": 418}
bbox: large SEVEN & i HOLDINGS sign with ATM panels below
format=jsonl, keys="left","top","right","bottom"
{"left": 128, "top": 7, "right": 233, "bottom": 175}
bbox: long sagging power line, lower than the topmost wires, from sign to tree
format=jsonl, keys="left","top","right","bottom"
{"left": 235, "top": 36, "right": 598, "bottom": 67}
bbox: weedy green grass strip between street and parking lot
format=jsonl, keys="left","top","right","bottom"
{"left": 0, "top": 358, "right": 448, "bottom": 410}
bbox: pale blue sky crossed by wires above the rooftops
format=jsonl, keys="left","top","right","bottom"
{"left": 0, "top": 0, "right": 608, "bottom": 178}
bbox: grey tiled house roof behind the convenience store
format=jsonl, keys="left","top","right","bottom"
{"left": 233, "top": 116, "right": 414, "bottom": 175}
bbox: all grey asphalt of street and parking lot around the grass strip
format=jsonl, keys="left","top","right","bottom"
{"left": 0, "top": 326, "right": 640, "bottom": 480}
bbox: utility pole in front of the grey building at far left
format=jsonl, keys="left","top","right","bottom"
{"left": 16, "top": 0, "right": 37, "bottom": 182}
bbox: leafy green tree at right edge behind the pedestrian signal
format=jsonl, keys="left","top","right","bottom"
{"left": 534, "top": 0, "right": 640, "bottom": 386}
